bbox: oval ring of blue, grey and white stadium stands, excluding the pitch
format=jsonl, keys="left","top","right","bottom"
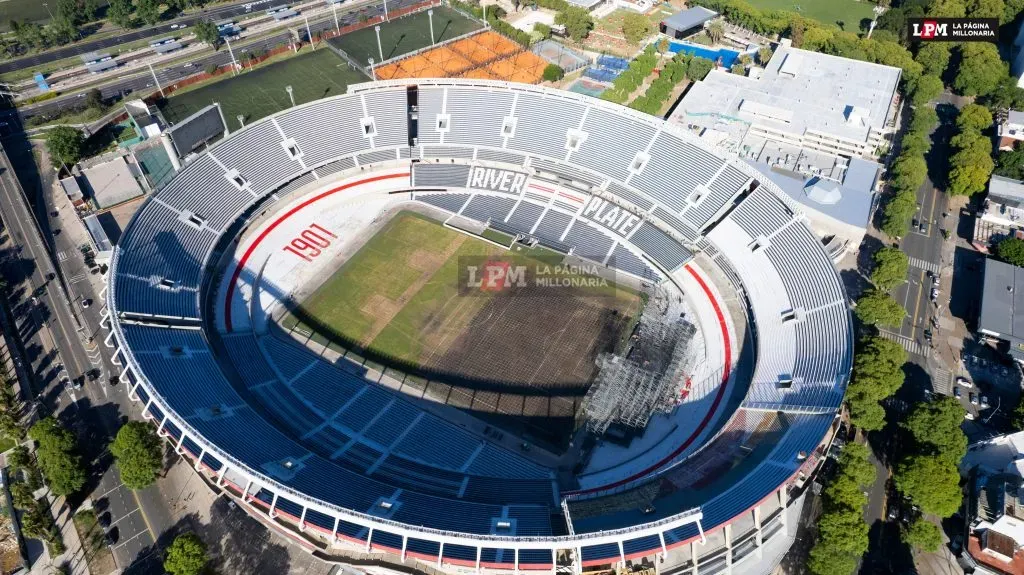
{"left": 106, "top": 79, "right": 852, "bottom": 574}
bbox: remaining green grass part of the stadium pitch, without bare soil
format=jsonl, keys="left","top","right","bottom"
{"left": 290, "top": 212, "right": 641, "bottom": 365}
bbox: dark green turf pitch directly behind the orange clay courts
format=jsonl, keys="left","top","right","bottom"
{"left": 328, "top": 6, "right": 483, "bottom": 65}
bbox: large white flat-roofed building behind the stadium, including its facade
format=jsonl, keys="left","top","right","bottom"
{"left": 670, "top": 40, "right": 901, "bottom": 161}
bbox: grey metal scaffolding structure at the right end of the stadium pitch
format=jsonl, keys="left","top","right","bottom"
{"left": 581, "top": 286, "right": 697, "bottom": 435}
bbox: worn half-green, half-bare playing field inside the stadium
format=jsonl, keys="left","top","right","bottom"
{"left": 283, "top": 212, "right": 641, "bottom": 444}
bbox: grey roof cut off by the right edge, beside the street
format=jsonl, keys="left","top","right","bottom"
{"left": 978, "top": 258, "right": 1024, "bottom": 359}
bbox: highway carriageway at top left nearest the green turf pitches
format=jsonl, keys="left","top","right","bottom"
{"left": 0, "top": 0, "right": 419, "bottom": 121}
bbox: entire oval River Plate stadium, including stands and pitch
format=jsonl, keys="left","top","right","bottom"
{"left": 104, "top": 79, "right": 853, "bottom": 573}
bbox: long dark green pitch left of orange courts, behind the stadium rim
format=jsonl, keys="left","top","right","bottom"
{"left": 161, "top": 46, "right": 368, "bottom": 125}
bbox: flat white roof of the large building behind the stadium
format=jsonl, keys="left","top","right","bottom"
{"left": 674, "top": 45, "right": 900, "bottom": 146}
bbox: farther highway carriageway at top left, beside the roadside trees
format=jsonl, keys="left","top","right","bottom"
{"left": 0, "top": 0, "right": 288, "bottom": 74}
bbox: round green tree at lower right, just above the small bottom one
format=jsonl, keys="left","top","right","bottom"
{"left": 894, "top": 455, "right": 963, "bottom": 518}
